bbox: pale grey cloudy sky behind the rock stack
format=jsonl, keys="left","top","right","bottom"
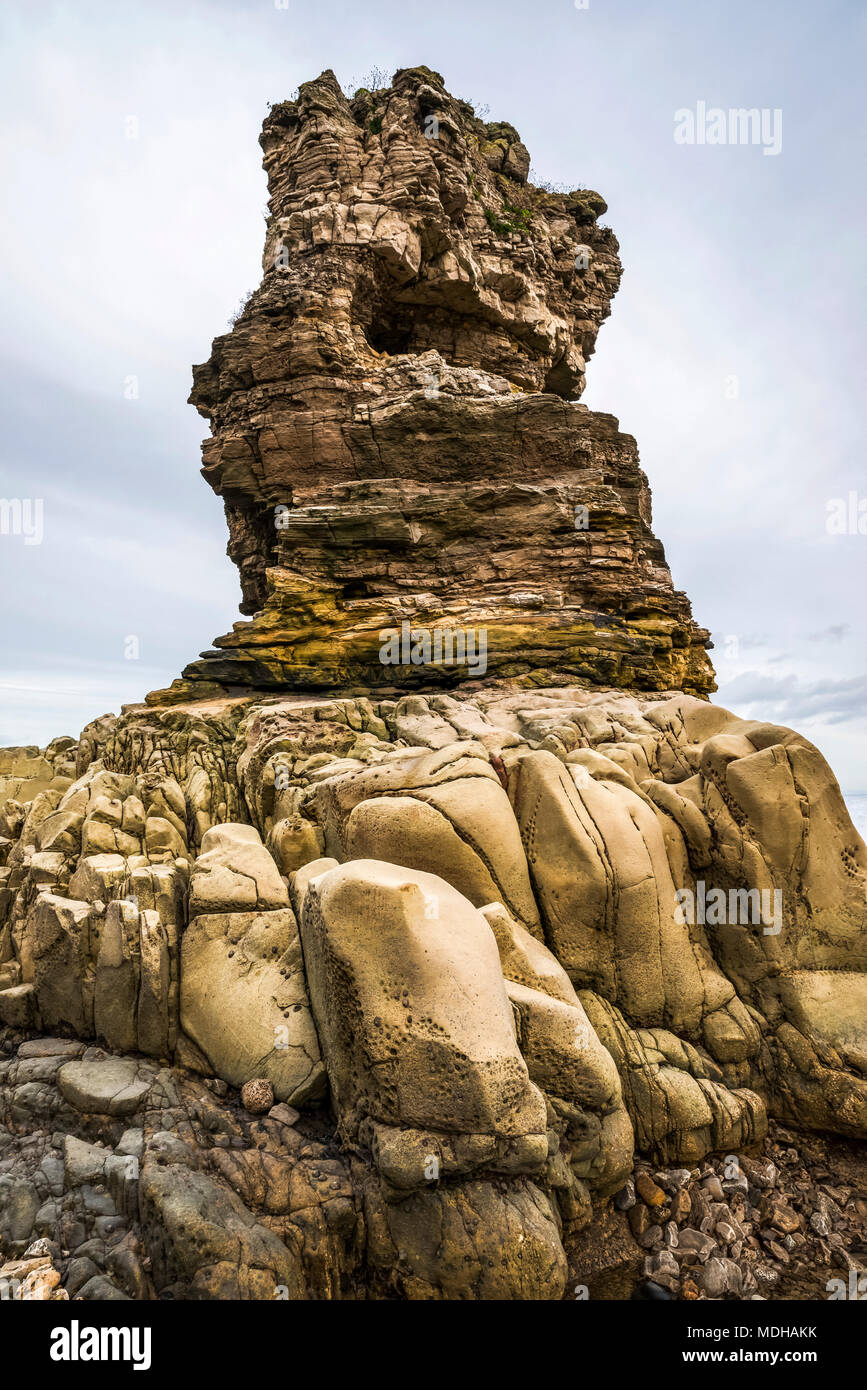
{"left": 0, "top": 0, "right": 867, "bottom": 792}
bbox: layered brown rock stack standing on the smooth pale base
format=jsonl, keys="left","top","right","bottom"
{"left": 150, "top": 68, "right": 714, "bottom": 703}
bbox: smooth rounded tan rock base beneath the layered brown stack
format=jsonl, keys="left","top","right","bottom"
{"left": 0, "top": 688, "right": 867, "bottom": 1298}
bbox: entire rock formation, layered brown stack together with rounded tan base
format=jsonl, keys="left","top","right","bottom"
{"left": 0, "top": 68, "right": 867, "bottom": 1300}
